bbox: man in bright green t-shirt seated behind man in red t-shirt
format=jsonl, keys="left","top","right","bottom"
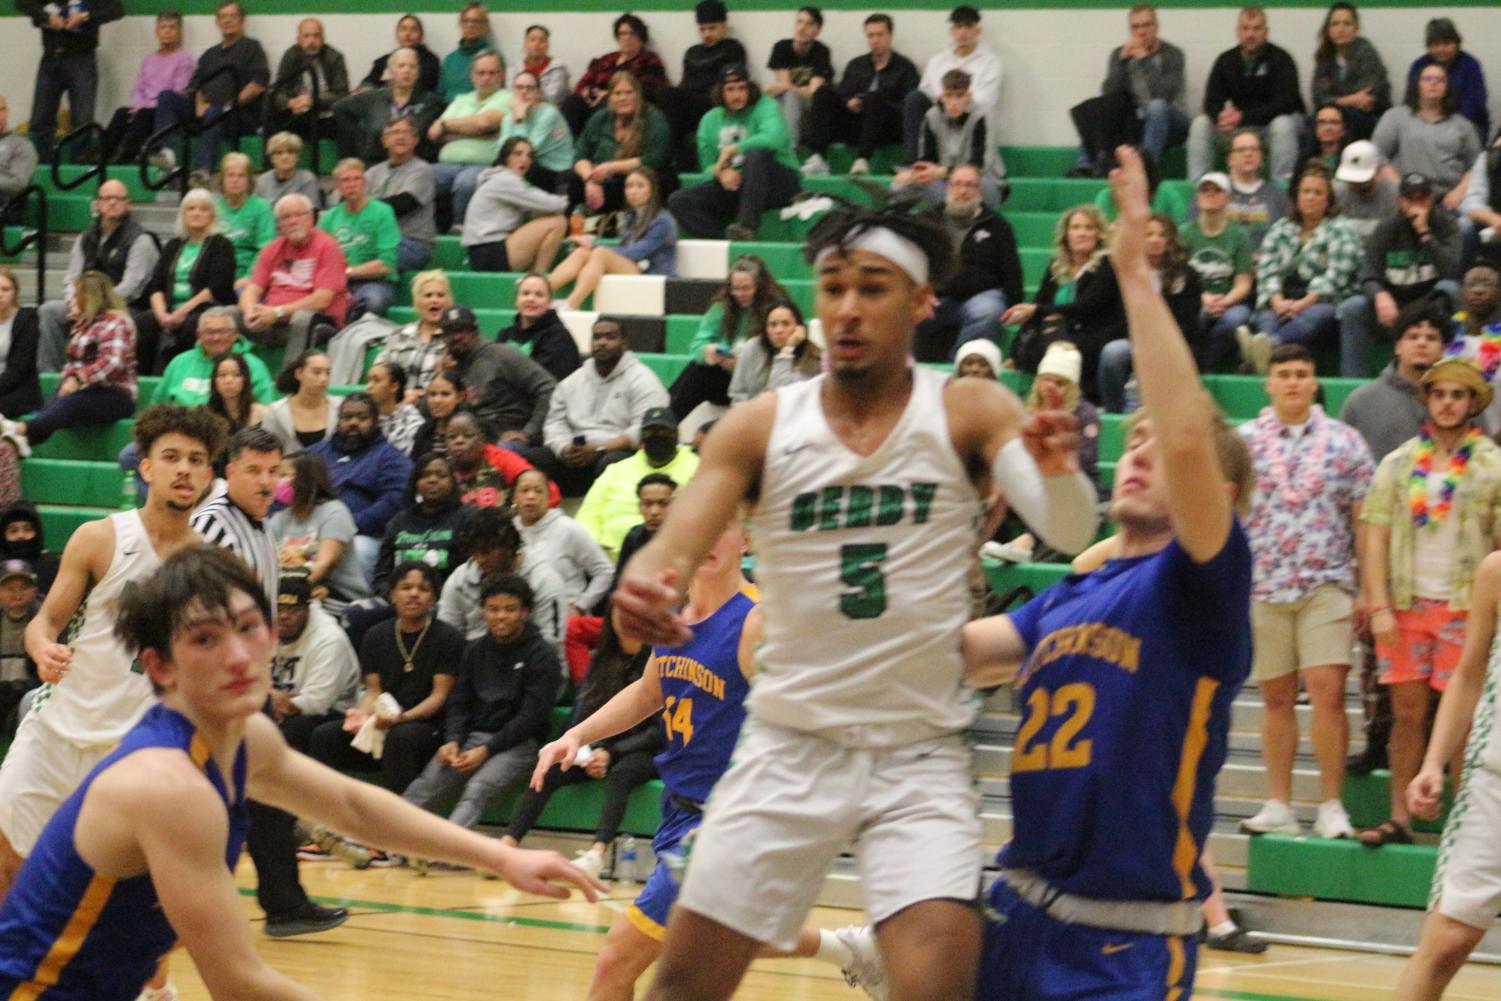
{"left": 318, "top": 156, "right": 401, "bottom": 321}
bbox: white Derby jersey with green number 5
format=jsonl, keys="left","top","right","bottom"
{"left": 747, "top": 368, "right": 982, "bottom": 747}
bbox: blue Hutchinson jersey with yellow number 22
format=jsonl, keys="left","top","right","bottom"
{"left": 998, "top": 522, "right": 1250, "bottom": 900}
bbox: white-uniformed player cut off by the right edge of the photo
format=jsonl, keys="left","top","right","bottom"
{"left": 1393, "top": 552, "right": 1501, "bottom": 1001}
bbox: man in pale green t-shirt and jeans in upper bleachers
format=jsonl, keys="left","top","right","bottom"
{"left": 428, "top": 50, "right": 510, "bottom": 225}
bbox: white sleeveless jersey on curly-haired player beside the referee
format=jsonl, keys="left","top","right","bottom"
{"left": 32, "top": 510, "right": 162, "bottom": 746}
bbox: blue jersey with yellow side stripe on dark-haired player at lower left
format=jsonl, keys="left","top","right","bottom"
{"left": 0, "top": 704, "right": 249, "bottom": 1001}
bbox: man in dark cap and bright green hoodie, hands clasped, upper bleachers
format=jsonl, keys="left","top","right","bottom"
{"left": 668, "top": 63, "right": 803, "bottom": 240}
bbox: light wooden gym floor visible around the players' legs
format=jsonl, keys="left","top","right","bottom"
{"left": 158, "top": 861, "right": 1501, "bottom": 1001}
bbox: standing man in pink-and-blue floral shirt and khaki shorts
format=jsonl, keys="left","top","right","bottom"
{"left": 1240, "top": 344, "right": 1376, "bottom": 837}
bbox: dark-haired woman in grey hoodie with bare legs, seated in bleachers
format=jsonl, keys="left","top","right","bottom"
{"left": 459, "top": 135, "right": 567, "bottom": 272}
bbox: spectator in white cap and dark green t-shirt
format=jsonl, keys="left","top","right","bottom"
{"left": 1180, "top": 171, "right": 1256, "bottom": 372}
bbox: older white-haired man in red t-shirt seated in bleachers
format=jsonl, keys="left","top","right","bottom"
{"left": 240, "top": 195, "right": 350, "bottom": 359}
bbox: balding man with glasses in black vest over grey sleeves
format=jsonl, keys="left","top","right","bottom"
{"left": 36, "top": 180, "right": 161, "bottom": 372}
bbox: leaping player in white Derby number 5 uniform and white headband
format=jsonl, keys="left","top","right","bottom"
{"left": 614, "top": 210, "right": 1097, "bottom": 1001}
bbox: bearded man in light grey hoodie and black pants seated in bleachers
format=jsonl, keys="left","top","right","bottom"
{"left": 534, "top": 317, "right": 668, "bottom": 497}
